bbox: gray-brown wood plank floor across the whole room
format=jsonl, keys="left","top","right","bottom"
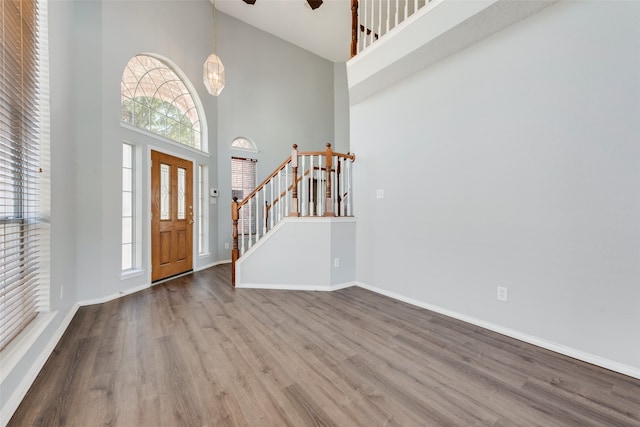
{"left": 9, "top": 265, "right": 640, "bottom": 427}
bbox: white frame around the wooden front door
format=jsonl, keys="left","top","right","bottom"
{"left": 148, "top": 144, "right": 198, "bottom": 285}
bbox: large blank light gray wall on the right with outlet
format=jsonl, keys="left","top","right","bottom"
{"left": 351, "top": 2, "right": 640, "bottom": 375}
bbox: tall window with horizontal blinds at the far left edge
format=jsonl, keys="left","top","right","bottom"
{"left": 0, "top": 0, "right": 42, "bottom": 350}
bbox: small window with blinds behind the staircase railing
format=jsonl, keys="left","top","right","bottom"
{"left": 231, "top": 157, "right": 257, "bottom": 234}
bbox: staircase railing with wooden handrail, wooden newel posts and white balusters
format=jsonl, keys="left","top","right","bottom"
{"left": 231, "top": 144, "right": 355, "bottom": 286}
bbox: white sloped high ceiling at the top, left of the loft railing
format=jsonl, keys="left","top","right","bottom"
{"left": 215, "top": 0, "right": 351, "bottom": 62}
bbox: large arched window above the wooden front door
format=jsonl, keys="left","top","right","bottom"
{"left": 121, "top": 55, "right": 206, "bottom": 151}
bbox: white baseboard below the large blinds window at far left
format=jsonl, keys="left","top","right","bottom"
{"left": 0, "top": 304, "right": 80, "bottom": 426}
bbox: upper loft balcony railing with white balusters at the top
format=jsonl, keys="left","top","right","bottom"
{"left": 351, "top": 0, "right": 438, "bottom": 58}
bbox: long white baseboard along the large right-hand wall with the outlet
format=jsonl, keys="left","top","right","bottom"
{"left": 355, "top": 282, "right": 640, "bottom": 379}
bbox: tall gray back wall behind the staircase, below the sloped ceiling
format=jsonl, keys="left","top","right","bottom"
{"left": 216, "top": 13, "right": 335, "bottom": 259}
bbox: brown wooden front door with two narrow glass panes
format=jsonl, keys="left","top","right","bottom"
{"left": 151, "top": 151, "right": 193, "bottom": 281}
